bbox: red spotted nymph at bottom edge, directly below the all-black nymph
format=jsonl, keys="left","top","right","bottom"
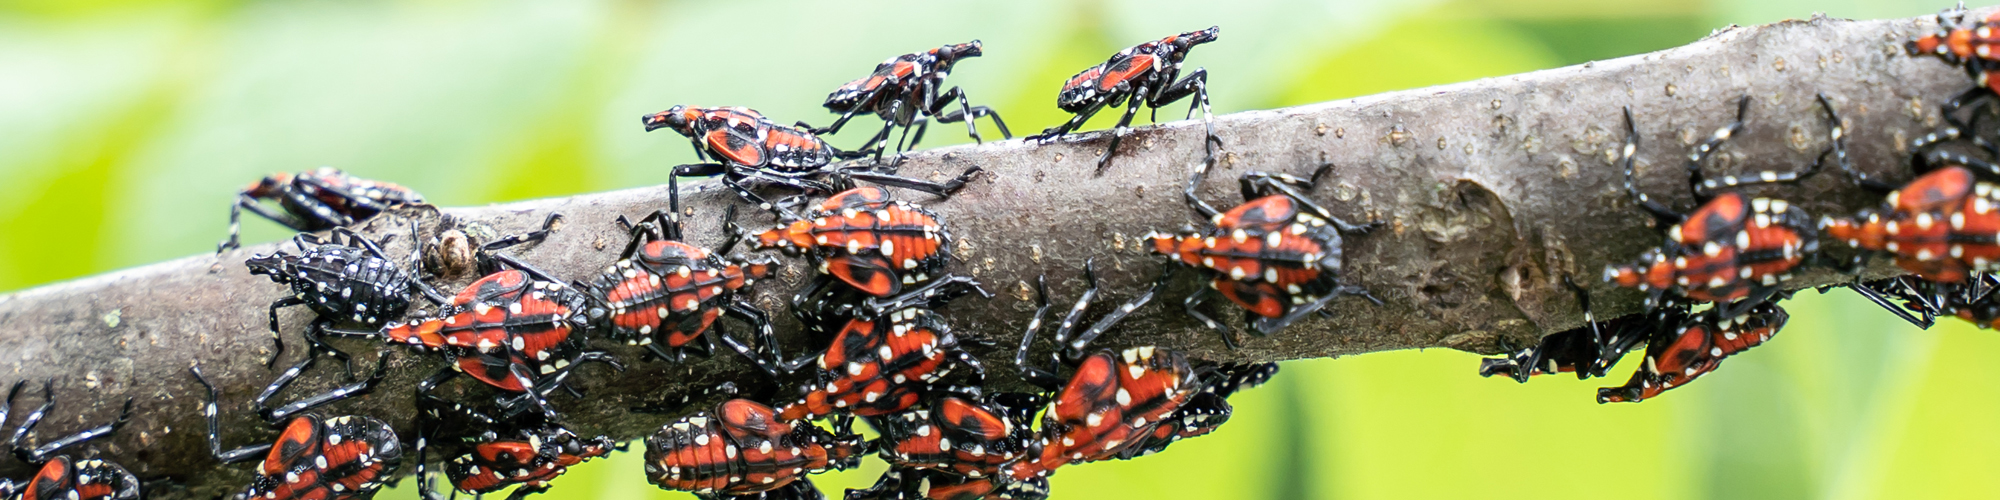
{"left": 188, "top": 362, "right": 402, "bottom": 500}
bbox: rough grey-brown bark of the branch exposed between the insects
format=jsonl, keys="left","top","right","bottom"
{"left": 0, "top": 9, "right": 1970, "bottom": 498}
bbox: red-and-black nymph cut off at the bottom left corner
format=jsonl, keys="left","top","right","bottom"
{"left": 0, "top": 380, "right": 140, "bottom": 500}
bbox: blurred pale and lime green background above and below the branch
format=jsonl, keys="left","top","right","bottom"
{"left": 0, "top": 0, "right": 2000, "bottom": 500}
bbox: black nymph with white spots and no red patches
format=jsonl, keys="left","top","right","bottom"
{"left": 244, "top": 222, "right": 448, "bottom": 372}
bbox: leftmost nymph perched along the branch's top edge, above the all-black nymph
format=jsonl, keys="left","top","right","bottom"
{"left": 216, "top": 168, "right": 424, "bottom": 254}
